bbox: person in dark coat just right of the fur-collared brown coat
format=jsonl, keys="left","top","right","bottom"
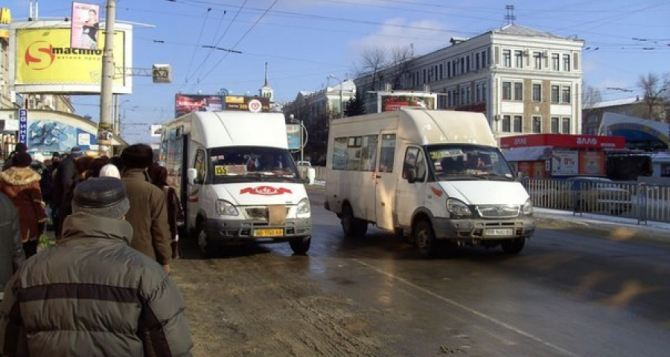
{"left": 51, "top": 146, "right": 82, "bottom": 238}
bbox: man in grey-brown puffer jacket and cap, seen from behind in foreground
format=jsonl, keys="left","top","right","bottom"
{"left": 0, "top": 177, "right": 193, "bottom": 356}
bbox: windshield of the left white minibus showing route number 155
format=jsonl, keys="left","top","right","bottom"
{"left": 208, "top": 146, "right": 299, "bottom": 184}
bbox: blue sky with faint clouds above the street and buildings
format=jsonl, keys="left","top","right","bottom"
{"left": 2, "top": 0, "right": 670, "bottom": 143}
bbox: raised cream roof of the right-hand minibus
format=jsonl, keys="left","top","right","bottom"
{"left": 331, "top": 108, "right": 498, "bottom": 147}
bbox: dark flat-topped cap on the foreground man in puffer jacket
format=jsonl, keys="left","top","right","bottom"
{"left": 72, "top": 177, "right": 130, "bottom": 219}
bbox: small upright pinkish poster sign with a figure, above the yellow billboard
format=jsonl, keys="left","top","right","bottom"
{"left": 70, "top": 2, "right": 102, "bottom": 49}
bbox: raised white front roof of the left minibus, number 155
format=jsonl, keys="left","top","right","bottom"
{"left": 189, "top": 111, "right": 288, "bottom": 149}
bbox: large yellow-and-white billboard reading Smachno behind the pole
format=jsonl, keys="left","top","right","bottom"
{"left": 10, "top": 21, "right": 132, "bottom": 94}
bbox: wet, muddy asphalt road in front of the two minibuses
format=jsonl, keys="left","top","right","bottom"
{"left": 173, "top": 190, "right": 670, "bottom": 356}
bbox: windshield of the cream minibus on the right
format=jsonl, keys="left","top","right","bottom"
{"left": 426, "top": 144, "right": 514, "bottom": 181}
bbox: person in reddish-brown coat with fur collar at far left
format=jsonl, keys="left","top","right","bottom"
{"left": 0, "top": 153, "right": 46, "bottom": 258}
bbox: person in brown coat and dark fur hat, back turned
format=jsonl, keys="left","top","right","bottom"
{"left": 121, "top": 144, "right": 172, "bottom": 272}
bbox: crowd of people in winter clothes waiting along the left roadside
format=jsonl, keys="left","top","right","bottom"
{"left": 0, "top": 144, "right": 192, "bottom": 356}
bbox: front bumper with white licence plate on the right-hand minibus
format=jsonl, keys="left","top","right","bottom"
{"left": 433, "top": 216, "right": 535, "bottom": 240}
